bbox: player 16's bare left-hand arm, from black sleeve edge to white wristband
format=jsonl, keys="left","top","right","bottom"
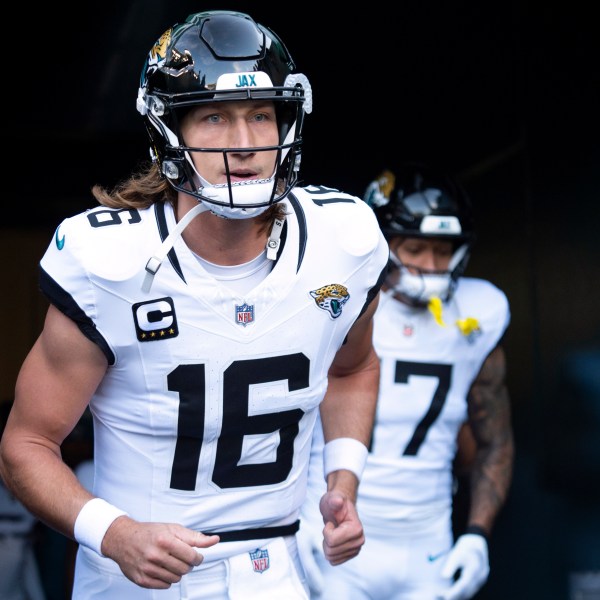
{"left": 0, "top": 306, "right": 107, "bottom": 537}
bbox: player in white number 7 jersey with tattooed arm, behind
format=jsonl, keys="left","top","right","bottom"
{"left": 299, "top": 163, "right": 513, "bottom": 600}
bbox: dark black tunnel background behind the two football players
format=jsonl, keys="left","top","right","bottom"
{"left": 0, "top": 0, "right": 600, "bottom": 600}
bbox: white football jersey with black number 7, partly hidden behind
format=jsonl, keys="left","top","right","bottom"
{"left": 310, "top": 277, "right": 510, "bottom": 534}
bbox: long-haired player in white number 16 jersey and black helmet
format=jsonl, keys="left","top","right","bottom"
{"left": 1, "top": 10, "right": 389, "bottom": 600}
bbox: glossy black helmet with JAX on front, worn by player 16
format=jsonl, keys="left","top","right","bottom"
{"left": 137, "top": 10, "right": 312, "bottom": 218}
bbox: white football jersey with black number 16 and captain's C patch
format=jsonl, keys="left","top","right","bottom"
{"left": 40, "top": 186, "right": 389, "bottom": 554}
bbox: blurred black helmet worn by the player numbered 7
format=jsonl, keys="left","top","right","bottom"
{"left": 364, "top": 163, "right": 475, "bottom": 305}
